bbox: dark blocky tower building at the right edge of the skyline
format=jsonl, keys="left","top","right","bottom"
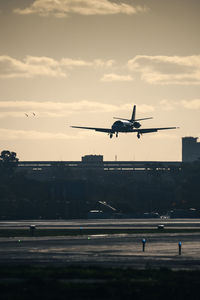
{"left": 182, "top": 136, "right": 200, "bottom": 162}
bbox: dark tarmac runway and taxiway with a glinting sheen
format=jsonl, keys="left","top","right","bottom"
{"left": 0, "top": 219, "right": 200, "bottom": 270}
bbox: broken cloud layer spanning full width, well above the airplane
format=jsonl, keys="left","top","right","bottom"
{"left": 0, "top": 55, "right": 200, "bottom": 85}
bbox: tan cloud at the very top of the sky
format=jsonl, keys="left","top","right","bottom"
{"left": 14, "top": 0, "right": 147, "bottom": 18}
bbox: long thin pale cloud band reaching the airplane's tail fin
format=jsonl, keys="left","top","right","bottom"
{"left": 0, "top": 100, "right": 154, "bottom": 119}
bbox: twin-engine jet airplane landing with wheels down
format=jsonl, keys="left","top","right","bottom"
{"left": 70, "top": 105, "right": 178, "bottom": 139}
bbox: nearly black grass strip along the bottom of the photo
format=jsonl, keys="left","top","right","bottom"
{"left": 0, "top": 265, "right": 200, "bottom": 300}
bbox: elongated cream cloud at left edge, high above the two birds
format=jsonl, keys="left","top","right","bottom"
{"left": 0, "top": 55, "right": 115, "bottom": 78}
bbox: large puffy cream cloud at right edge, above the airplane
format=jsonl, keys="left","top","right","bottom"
{"left": 128, "top": 55, "right": 200, "bottom": 85}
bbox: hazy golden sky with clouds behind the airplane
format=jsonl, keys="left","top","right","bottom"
{"left": 0, "top": 0, "right": 200, "bottom": 161}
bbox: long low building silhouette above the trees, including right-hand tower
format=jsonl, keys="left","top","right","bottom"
{"left": 17, "top": 137, "right": 200, "bottom": 181}
